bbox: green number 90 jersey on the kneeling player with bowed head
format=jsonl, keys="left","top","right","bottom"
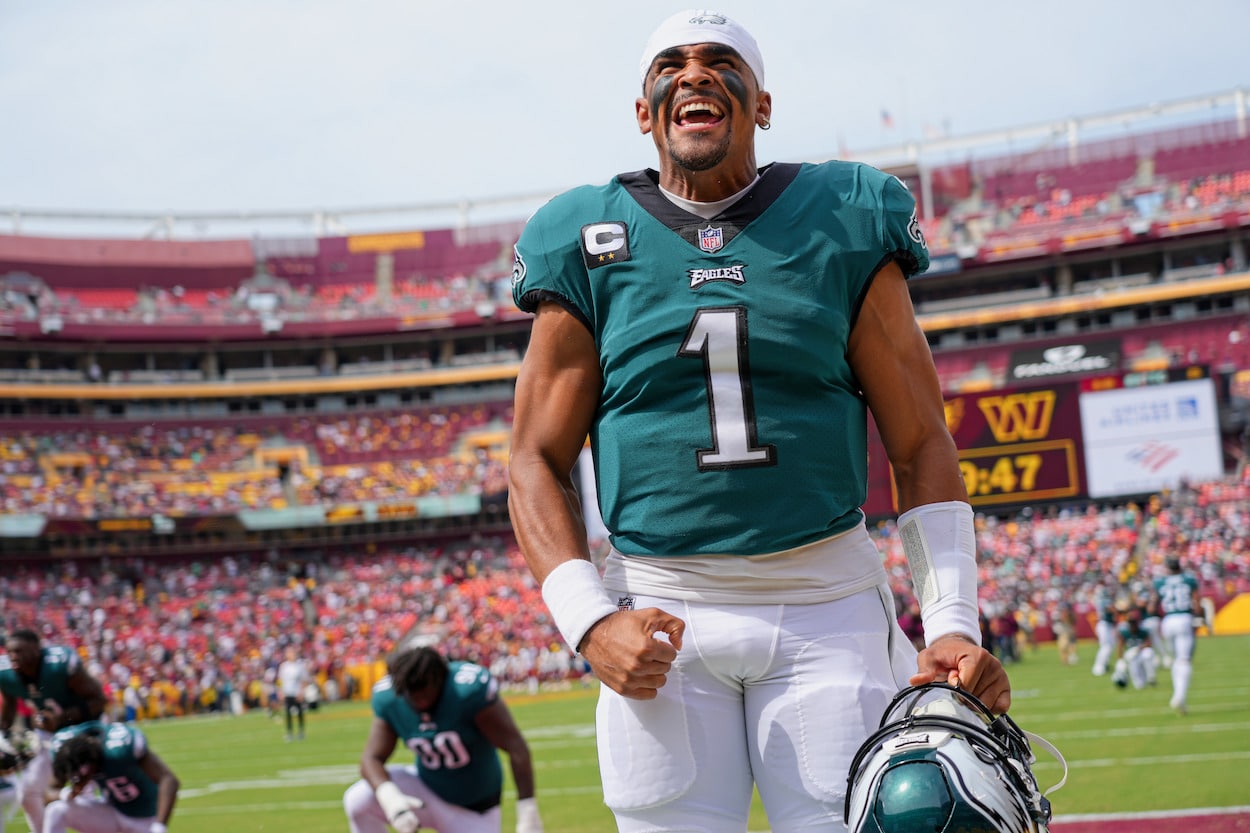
{"left": 373, "top": 662, "right": 504, "bottom": 808}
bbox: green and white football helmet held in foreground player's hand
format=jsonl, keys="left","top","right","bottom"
{"left": 844, "top": 683, "right": 1068, "bottom": 833}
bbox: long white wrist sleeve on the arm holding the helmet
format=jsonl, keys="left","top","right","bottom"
{"left": 899, "top": 500, "right": 981, "bottom": 645}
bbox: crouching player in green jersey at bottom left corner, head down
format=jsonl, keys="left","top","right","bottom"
{"left": 43, "top": 722, "right": 179, "bottom": 833}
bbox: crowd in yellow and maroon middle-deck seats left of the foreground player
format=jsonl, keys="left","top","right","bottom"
{"left": 0, "top": 403, "right": 510, "bottom": 519}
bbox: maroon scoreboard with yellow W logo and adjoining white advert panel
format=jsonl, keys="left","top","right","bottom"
{"left": 864, "top": 365, "right": 1224, "bottom": 518}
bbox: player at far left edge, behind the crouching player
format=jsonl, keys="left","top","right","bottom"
{"left": 0, "top": 629, "right": 108, "bottom": 830}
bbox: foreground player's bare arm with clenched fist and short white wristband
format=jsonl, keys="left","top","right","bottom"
{"left": 508, "top": 303, "right": 685, "bottom": 699}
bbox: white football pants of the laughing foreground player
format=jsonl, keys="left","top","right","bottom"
{"left": 596, "top": 587, "right": 916, "bottom": 833}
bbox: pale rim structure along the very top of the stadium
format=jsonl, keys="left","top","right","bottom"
{"left": 0, "top": 86, "right": 1250, "bottom": 240}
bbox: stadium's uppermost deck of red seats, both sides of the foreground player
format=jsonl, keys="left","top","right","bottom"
{"left": 0, "top": 90, "right": 1250, "bottom": 346}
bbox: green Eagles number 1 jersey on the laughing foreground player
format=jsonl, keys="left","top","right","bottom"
{"left": 513, "top": 161, "right": 929, "bottom": 555}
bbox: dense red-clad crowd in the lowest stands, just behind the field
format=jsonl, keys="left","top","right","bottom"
{"left": 0, "top": 473, "right": 1250, "bottom": 717}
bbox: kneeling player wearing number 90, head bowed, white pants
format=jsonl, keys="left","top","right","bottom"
{"left": 343, "top": 645, "right": 543, "bottom": 833}
